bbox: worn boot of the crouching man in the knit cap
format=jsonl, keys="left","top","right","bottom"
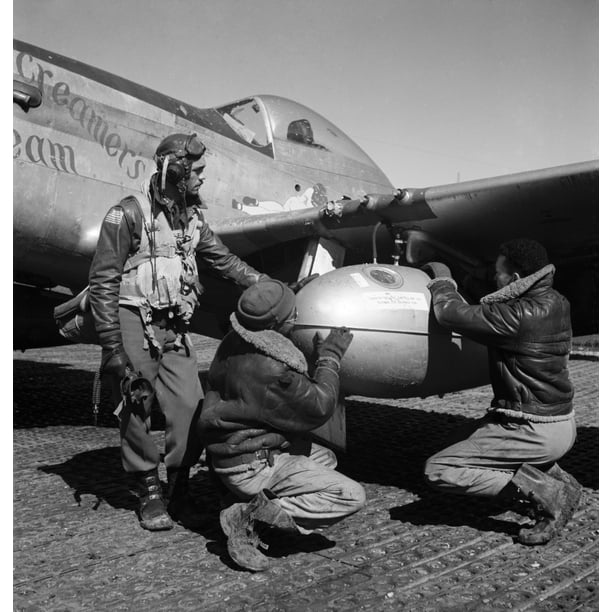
{"left": 219, "top": 494, "right": 270, "bottom": 572}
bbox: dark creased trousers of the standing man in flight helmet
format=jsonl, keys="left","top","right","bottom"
{"left": 113, "top": 307, "right": 204, "bottom": 472}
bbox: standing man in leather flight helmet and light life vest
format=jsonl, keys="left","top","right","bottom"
{"left": 89, "top": 134, "right": 267, "bottom": 531}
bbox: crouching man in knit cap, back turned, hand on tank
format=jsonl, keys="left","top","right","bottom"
{"left": 199, "top": 280, "right": 365, "bottom": 571}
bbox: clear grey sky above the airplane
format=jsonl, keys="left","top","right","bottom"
{"left": 13, "top": 0, "right": 598, "bottom": 187}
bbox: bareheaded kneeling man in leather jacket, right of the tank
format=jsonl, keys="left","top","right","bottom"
{"left": 423, "top": 239, "right": 581, "bottom": 545}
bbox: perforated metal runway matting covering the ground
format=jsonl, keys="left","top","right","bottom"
{"left": 13, "top": 337, "right": 599, "bottom": 612}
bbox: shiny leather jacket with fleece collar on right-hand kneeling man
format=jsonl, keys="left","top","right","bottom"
{"left": 429, "top": 265, "right": 574, "bottom": 420}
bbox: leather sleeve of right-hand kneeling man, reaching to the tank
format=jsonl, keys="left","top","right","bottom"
{"left": 429, "top": 280, "right": 521, "bottom": 344}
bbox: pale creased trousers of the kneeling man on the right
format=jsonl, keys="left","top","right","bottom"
{"left": 425, "top": 411, "right": 576, "bottom": 497}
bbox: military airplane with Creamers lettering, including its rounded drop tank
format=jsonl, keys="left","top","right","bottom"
{"left": 13, "top": 40, "right": 599, "bottom": 448}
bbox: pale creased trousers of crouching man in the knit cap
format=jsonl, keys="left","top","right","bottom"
{"left": 213, "top": 444, "right": 365, "bottom": 529}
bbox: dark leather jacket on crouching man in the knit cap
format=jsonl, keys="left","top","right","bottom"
{"left": 198, "top": 322, "right": 340, "bottom": 467}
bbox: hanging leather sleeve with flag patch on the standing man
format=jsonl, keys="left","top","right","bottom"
{"left": 89, "top": 201, "right": 140, "bottom": 347}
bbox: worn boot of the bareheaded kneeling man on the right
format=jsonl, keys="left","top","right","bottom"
{"left": 511, "top": 464, "right": 581, "bottom": 546}
